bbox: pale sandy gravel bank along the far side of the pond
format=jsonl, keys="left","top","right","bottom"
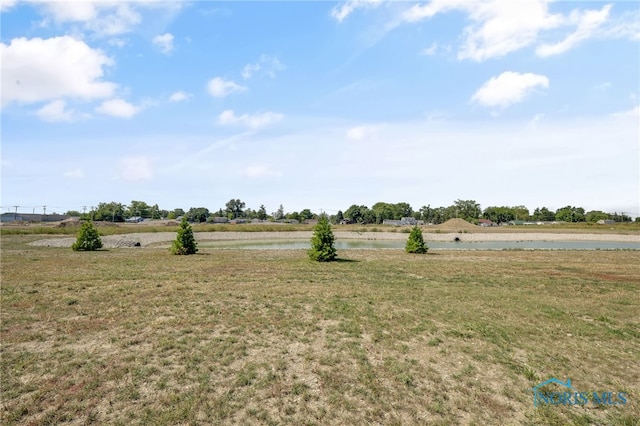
{"left": 29, "top": 231, "right": 640, "bottom": 248}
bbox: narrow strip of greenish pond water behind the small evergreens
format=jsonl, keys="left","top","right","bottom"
{"left": 198, "top": 240, "right": 640, "bottom": 250}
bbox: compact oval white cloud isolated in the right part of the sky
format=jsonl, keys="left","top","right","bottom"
{"left": 471, "top": 71, "right": 549, "bottom": 108}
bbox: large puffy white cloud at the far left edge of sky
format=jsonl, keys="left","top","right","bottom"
{"left": 0, "top": 36, "right": 116, "bottom": 105}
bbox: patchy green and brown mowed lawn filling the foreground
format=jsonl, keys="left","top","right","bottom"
{"left": 0, "top": 235, "right": 640, "bottom": 425}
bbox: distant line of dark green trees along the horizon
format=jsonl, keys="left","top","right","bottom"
{"left": 66, "top": 199, "right": 640, "bottom": 224}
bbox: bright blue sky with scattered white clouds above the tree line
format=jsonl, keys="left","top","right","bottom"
{"left": 0, "top": 0, "right": 640, "bottom": 216}
